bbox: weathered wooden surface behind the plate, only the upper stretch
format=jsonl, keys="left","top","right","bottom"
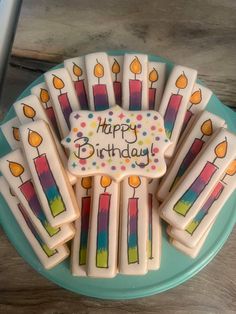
{"left": 1, "top": 0, "right": 236, "bottom": 119}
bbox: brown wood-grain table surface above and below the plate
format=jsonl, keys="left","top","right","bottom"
{"left": 0, "top": 0, "right": 236, "bottom": 314}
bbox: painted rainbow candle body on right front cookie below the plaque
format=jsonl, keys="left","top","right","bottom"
{"left": 127, "top": 197, "right": 139, "bottom": 264}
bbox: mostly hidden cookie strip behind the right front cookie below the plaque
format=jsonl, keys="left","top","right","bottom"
{"left": 147, "top": 179, "right": 162, "bottom": 270}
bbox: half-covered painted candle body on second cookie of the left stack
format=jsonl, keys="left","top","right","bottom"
{"left": 19, "top": 180, "right": 60, "bottom": 237}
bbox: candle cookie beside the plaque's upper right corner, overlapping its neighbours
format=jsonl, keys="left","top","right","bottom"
{"left": 159, "top": 65, "right": 197, "bottom": 158}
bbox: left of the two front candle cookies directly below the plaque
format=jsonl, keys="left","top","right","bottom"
{"left": 87, "top": 175, "right": 119, "bottom": 278}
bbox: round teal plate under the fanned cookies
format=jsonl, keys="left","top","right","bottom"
{"left": 0, "top": 52, "right": 236, "bottom": 299}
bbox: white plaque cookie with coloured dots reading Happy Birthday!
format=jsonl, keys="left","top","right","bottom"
{"left": 62, "top": 106, "right": 169, "bottom": 181}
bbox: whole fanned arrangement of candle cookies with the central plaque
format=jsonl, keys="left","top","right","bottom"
{"left": 0, "top": 52, "right": 236, "bottom": 278}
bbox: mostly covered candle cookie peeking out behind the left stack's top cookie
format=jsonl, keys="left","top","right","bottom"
{"left": 14, "top": 95, "right": 76, "bottom": 184}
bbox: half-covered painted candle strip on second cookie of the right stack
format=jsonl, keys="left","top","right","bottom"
{"left": 185, "top": 182, "right": 225, "bottom": 235}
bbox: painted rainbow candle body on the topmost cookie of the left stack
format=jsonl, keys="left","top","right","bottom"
{"left": 34, "top": 154, "right": 66, "bottom": 217}
